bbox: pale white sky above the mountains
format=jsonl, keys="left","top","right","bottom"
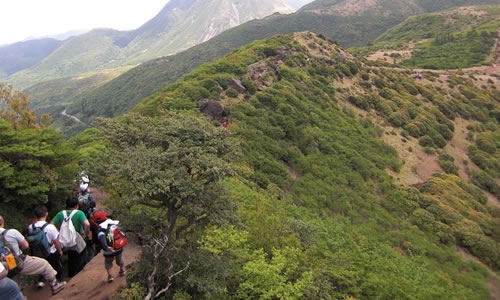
{"left": 0, "top": 0, "right": 168, "bottom": 45}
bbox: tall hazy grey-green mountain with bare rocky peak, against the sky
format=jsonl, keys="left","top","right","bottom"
{"left": 4, "top": 0, "right": 293, "bottom": 88}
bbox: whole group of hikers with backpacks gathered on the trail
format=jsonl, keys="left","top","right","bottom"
{"left": 0, "top": 172, "right": 127, "bottom": 300}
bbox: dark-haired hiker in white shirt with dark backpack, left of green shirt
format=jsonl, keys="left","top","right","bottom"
{"left": 28, "top": 205, "right": 63, "bottom": 287}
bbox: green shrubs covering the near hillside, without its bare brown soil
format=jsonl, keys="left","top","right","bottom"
{"left": 120, "top": 33, "right": 496, "bottom": 299}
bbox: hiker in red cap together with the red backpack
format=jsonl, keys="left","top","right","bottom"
{"left": 92, "top": 211, "right": 126, "bottom": 282}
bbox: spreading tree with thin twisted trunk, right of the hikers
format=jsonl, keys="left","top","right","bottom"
{"left": 98, "top": 113, "right": 236, "bottom": 300}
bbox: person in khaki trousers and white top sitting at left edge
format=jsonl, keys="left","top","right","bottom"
{"left": 0, "top": 216, "right": 66, "bottom": 294}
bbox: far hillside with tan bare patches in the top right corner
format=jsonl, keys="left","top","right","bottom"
{"left": 356, "top": 6, "right": 500, "bottom": 69}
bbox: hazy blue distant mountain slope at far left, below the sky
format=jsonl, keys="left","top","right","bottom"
{"left": 0, "top": 38, "right": 63, "bottom": 78}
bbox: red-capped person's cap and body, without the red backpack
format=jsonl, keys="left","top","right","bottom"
{"left": 92, "top": 211, "right": 125, "bottom": 282}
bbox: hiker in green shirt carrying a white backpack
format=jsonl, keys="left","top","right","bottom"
{"left": 51, "top": 197, "right": 90, "bottom": 277}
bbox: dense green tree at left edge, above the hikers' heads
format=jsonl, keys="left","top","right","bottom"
{"left": 0, "top": 84, "right": 76, "bottom": 228}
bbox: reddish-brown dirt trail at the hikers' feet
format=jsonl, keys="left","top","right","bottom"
{"left": 23, "top": 187, "right": 141, "bottom": 300}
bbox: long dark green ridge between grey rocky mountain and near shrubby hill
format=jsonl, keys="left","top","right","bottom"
{"left": 63, "top": 1, "right": 495, "bottom": 134}
